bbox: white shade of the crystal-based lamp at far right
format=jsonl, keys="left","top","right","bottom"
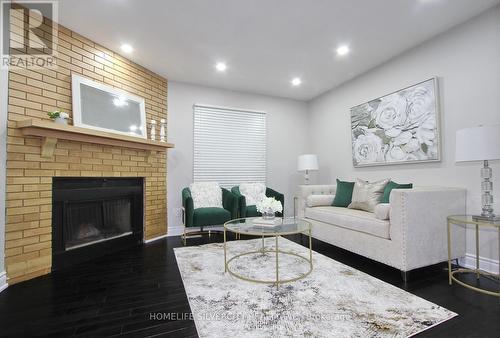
{"left": 455, "top": 124, "right": 500, "bottom": 162}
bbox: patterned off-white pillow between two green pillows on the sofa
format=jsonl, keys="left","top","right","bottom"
{"left": 347, "top": 178, "right": 390, "bottom": 212}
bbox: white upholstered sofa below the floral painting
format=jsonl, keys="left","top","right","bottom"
{"left": 298, "top": 185, "right": 466, "bottom": 280}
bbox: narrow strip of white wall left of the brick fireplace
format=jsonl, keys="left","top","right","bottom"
{"left": 0, "top": 70, "right": 9, "bottom": 291}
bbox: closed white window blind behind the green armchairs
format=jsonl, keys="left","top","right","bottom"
{"left": 193, "top": 105, "right": 266, "bottom": 188}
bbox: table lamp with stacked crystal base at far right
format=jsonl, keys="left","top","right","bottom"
{"left": 455, "top": 124, "right": 500, "bottom": 221}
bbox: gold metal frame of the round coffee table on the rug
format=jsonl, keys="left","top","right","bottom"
{"left": 224, "top": 217, "right": 313, "bottom": 287}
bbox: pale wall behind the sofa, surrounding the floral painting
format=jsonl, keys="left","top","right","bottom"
{"left": 308, "top": 6, "right": 500, "bottom": 260}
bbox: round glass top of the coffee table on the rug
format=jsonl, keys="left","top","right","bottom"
{"left": 224, "top": 217, "right": 311, "bottom": 236}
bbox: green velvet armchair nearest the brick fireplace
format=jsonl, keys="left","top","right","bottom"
{"left": 182, "top": 188, "right": 238, "bottom": 241}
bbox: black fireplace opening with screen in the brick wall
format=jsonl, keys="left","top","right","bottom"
{"left": 52, "top": 177, "right": 144, "bottom": 270}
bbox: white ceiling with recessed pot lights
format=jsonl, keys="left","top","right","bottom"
{"left": 59, "top": 0, "right": 500, "bottom": 100}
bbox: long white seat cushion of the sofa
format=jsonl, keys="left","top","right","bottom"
{"left": 305, "top": 207, "right": 390, "bottom": 239}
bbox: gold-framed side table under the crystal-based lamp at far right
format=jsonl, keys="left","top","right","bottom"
{"left": 448, "top": 215, "right": 500, "bottom": 297}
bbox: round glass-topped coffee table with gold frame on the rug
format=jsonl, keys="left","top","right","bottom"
{"left": 224, "top": 217, "right": 313, "bottom": 287}
